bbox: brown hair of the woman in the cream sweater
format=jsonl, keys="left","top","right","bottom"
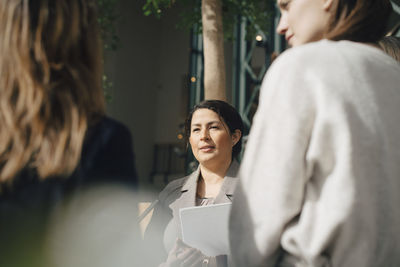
{"left": 324, "top": 0, "right": 393, "bottom": 43}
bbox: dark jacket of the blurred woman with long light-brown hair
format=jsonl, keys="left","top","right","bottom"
{"left": 0, "top": 117, "right": 137, "bottom": 266}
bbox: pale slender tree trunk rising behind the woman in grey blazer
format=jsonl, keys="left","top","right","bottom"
{"left": 201, "top": 0, "right": 226, "bottom": 101}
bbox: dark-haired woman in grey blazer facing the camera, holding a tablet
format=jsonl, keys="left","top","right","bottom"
{"left": 145, "top": 100, "right": 243, "bottom": 266}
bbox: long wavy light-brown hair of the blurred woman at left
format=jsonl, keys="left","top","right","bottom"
{"left": 0, "top": 0, "right": 104, "bottom": 182}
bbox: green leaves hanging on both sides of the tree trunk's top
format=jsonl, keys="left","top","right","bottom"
{"left": 143, "top": 0, "right": 275, "bottom": 40}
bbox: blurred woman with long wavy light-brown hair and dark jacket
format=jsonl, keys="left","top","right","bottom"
{"left": 0, "top": 0, "right": 137, "bottom": 266}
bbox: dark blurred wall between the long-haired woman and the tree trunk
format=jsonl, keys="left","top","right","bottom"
{"left": 105, "top": 0, "right": 232, "bottom": 193}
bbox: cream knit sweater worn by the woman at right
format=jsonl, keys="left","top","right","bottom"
{"left": 230, "top": 40, "right": 400, "bottom": 267}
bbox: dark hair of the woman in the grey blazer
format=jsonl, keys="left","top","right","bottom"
{"left": 185, "top": 100, "right": 244, "bottom": 158}
